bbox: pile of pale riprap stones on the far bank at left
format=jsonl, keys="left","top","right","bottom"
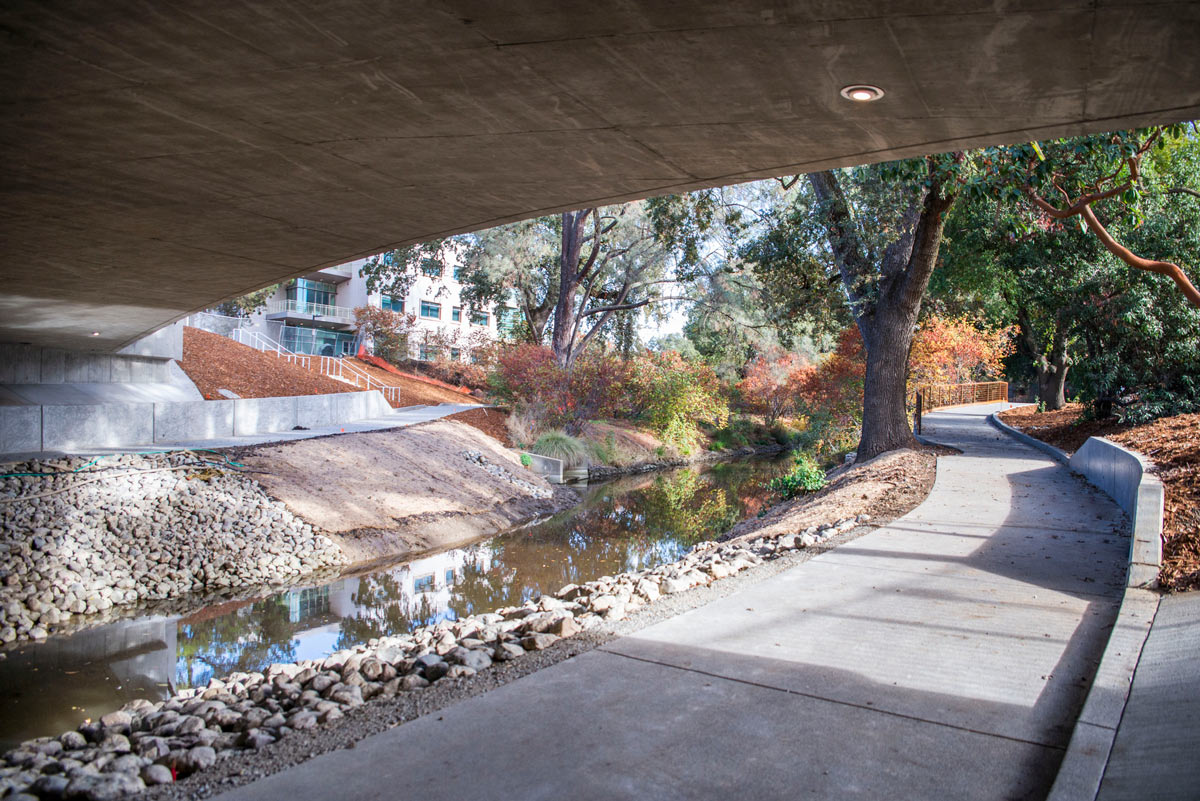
{"left": 0, "top": 451, "right": 344, "bottom": 643}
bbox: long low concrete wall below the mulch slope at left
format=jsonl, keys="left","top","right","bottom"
{"left": 0, "top": 390, "right": 391, "bottom": 458}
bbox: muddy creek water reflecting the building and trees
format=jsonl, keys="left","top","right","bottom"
{"left": 0, "top": 458, "right": 791, "bottom": 748}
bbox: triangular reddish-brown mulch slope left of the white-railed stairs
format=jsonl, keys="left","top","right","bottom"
{"left": 179, "top": 326, "right": 355, "bottom": 401}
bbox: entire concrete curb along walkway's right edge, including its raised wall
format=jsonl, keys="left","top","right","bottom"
{"left": 988, "top": 414, "right": 1164, "bottom": 801}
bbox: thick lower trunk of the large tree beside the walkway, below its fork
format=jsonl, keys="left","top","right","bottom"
{"left": 857, "top": 313, "right": 917, "bottom": 462}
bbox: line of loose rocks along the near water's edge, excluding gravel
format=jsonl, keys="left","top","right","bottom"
{"left": 0, "top": 516, "right": 868, "bottom": 800}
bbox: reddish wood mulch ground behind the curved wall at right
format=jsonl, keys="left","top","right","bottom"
{"left": 1000, "top": 404, "right": 1200, "bottom": 590}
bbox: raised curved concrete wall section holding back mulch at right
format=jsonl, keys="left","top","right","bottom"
{"left": 1070, "top": 436, "right": 1163, "bottom": 588}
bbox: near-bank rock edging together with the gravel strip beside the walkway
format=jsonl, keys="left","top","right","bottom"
{"left": 0, "top": 514, "right": 868, "bottom": 801}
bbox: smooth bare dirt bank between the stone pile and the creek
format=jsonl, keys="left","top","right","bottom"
{"left": 238, "top": 420, "right": 577, "bottom": 562}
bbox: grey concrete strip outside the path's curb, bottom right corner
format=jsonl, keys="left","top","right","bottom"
{"left": 1097, "top": 592, "right": 1200, "bottom": 801}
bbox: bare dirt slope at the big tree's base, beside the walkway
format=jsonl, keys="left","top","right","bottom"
{"left": 722, "top": 448, "right": 952, "bottom": 540}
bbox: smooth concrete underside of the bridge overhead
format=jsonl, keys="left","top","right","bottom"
{"left": 0, "top": 0, "right": 1200, "bottom": 349}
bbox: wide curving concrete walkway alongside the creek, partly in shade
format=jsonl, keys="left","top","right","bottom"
{"left": 220, "top": 406, "right": 1128, "bottom": 801}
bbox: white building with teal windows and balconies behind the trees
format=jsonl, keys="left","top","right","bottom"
{"left": 252, "top": 259, "right": 516, "bottom": 360}
